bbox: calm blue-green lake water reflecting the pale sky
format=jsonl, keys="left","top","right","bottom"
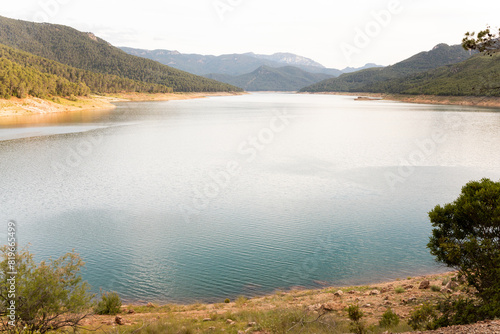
{"left": 0, "top": 94, "right": 500, "bottom": 302}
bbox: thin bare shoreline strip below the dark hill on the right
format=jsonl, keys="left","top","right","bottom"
{"left": 299, "top": 92, "right": 500, "bottom": 108}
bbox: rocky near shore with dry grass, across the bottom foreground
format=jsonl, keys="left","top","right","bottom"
{"left": 71, "top": 272, "right": 500, "bottom": 334}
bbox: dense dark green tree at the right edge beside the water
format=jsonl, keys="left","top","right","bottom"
{"left": 427, "top": 179, "right": 500, "bottom": 303}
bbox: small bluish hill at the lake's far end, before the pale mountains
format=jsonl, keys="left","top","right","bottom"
{"left": 203, "top": 66, "right": 331, "bottom": 91}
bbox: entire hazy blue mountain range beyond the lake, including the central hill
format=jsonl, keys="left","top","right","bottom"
{"left": 121, "top": 47, "right": 380, "bottom": 91}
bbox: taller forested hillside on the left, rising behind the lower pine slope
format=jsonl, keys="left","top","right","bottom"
{"left": 0, "top": 16, "right": 240, "bottom": 92}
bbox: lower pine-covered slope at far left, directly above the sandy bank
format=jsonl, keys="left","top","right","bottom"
{"left": 0, "top": 44, "right": 172, "bottom": 98}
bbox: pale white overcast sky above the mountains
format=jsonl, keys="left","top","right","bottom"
{"left": 0, "top": 0, "right": 500, "bottom": 69}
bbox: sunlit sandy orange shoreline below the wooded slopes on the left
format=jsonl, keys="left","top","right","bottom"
{"left": 0, "top": 92, "right": 244, "bottom": 117}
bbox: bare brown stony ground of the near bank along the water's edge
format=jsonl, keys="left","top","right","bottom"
{"left": 84, "top": 271, "right": 465, "bottom": 333}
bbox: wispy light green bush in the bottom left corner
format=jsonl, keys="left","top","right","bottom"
{"left": 0, "top": 247, "right": 92, "bottom": 333}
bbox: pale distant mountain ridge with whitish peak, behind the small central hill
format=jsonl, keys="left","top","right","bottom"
{"left": 121, "top": 47, "right": 342, "bottom": 76}
